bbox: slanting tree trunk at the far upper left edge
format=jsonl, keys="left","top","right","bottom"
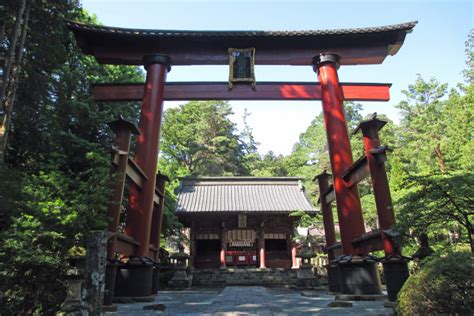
{"left": 0, "top": 0, "right": 31, "bottom": 164}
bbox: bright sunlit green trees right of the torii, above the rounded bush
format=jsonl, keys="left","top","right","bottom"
{"left": 390, "top": 71, "right": 474, "bottom": 252}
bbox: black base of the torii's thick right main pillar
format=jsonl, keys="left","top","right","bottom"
{"left": 337, "top": 256, "right": 382, "bottom": 295}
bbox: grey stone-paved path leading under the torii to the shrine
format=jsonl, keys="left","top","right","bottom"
{"left": 106, "top": 286, "right": 393, "bottom": 316}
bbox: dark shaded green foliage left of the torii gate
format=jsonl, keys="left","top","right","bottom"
{"left": 0, "top": 1, "right": 143, "bottom": 315}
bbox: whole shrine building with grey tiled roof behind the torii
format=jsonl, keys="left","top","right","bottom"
{"left": 176, "top": 177, "right": 316, "bottom": 269}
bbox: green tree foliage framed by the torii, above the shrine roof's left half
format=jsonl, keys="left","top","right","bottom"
{"left": 159, "top": 101, "right": 249, "bottom": 176}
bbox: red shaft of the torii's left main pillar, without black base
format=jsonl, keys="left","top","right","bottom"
{"left": 125, "top": 64, "right": 167, "bottom": 256}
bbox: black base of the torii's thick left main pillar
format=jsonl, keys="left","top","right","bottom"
{"left": 114, "top": 256, "right": 153, "bottom": 297}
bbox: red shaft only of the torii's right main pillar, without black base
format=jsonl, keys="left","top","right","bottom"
{"left": 317, "top": 55, "right": 365, "bottom": 255}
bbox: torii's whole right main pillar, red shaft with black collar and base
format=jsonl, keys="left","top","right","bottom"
{"left": 313, "top": 53, "right": 381, "bottom": 294}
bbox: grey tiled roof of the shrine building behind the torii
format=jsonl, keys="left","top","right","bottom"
{"left": 176, "top": 177, "right": 315, "bottom": 214}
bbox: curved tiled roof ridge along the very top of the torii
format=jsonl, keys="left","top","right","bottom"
{"left": 65, "top": 20, "right": 418, "bottom": 37}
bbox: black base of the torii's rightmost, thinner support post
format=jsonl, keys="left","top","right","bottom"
{"left": 382, "top": 258, "right": 410, "bottom": 302}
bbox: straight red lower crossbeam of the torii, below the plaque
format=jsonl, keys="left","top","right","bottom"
{"left": 92, "top": 82, "right": 391, "bottom": 102}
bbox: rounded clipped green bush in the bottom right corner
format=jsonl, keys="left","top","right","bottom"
{"left": 396, "top": 252, "right": 474, "bottom": 315}
